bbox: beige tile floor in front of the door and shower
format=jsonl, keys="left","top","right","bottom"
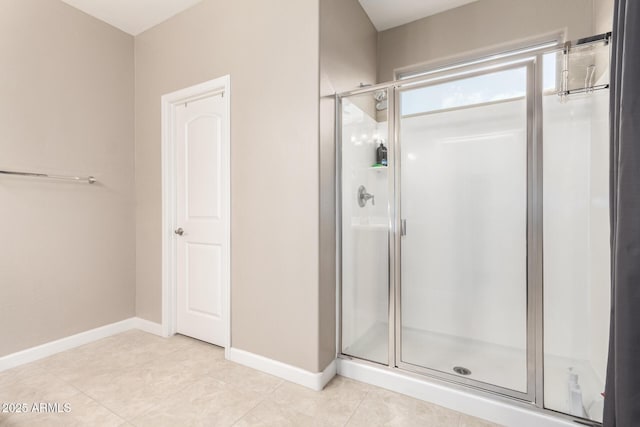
{"left": 0, "top": 331, "right": 495, "bottom": 427}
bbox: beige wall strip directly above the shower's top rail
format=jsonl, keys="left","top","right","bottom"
{"left": 377, "top": 0, "right": 592, "bottom": 82}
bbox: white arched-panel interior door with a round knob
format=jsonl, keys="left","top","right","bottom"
{"left": 174, "top": 94, "right": 229, "bottom": 346}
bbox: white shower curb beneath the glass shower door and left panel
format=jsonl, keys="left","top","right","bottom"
{"left": 337, "top": 359, "right": 576, "bottom": 427}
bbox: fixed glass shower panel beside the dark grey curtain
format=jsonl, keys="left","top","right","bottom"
{"left": 543, "top": 91, "right": 610, "bottom": 421}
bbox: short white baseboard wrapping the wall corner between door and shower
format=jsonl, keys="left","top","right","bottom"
{"left": 227, "top": 348, "right": 336, "bottom": 391}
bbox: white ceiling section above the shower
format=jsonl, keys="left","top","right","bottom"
{"left": 358, "top": 0, "right": 477, "bottom": 31}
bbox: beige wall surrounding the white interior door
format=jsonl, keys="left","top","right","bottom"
{"left": 135, "top": 0, "right": 324, "bottom": 372}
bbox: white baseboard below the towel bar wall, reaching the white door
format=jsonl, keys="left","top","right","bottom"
{"left": 0, "top": 317, "right": 162, "bottom": 372}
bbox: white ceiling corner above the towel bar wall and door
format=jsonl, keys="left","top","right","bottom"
{"left": 62, "top": 0, "right": 201, "bottom": 36}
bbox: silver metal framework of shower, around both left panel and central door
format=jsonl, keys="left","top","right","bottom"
{"left": 335, "top": 51, "right": 556, "bottom": 412}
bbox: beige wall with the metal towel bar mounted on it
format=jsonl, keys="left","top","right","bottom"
{"left": 0, "top": 0, "right": 135, "bottom": 356}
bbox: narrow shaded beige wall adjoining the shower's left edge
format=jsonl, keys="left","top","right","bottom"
{"left": 319, "top": 0, "right": 377, "bottom": 366}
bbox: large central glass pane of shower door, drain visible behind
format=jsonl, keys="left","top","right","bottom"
{"left": 396, "top": 63, "right": 535, "bottom": 397}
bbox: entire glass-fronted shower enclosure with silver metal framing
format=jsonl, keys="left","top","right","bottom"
{"left": 337, "top": 35, "right": 609, "bottom": 421}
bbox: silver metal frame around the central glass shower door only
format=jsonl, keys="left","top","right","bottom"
{"left": 389, "top": 56, "right": 542, "bottom": 403}
